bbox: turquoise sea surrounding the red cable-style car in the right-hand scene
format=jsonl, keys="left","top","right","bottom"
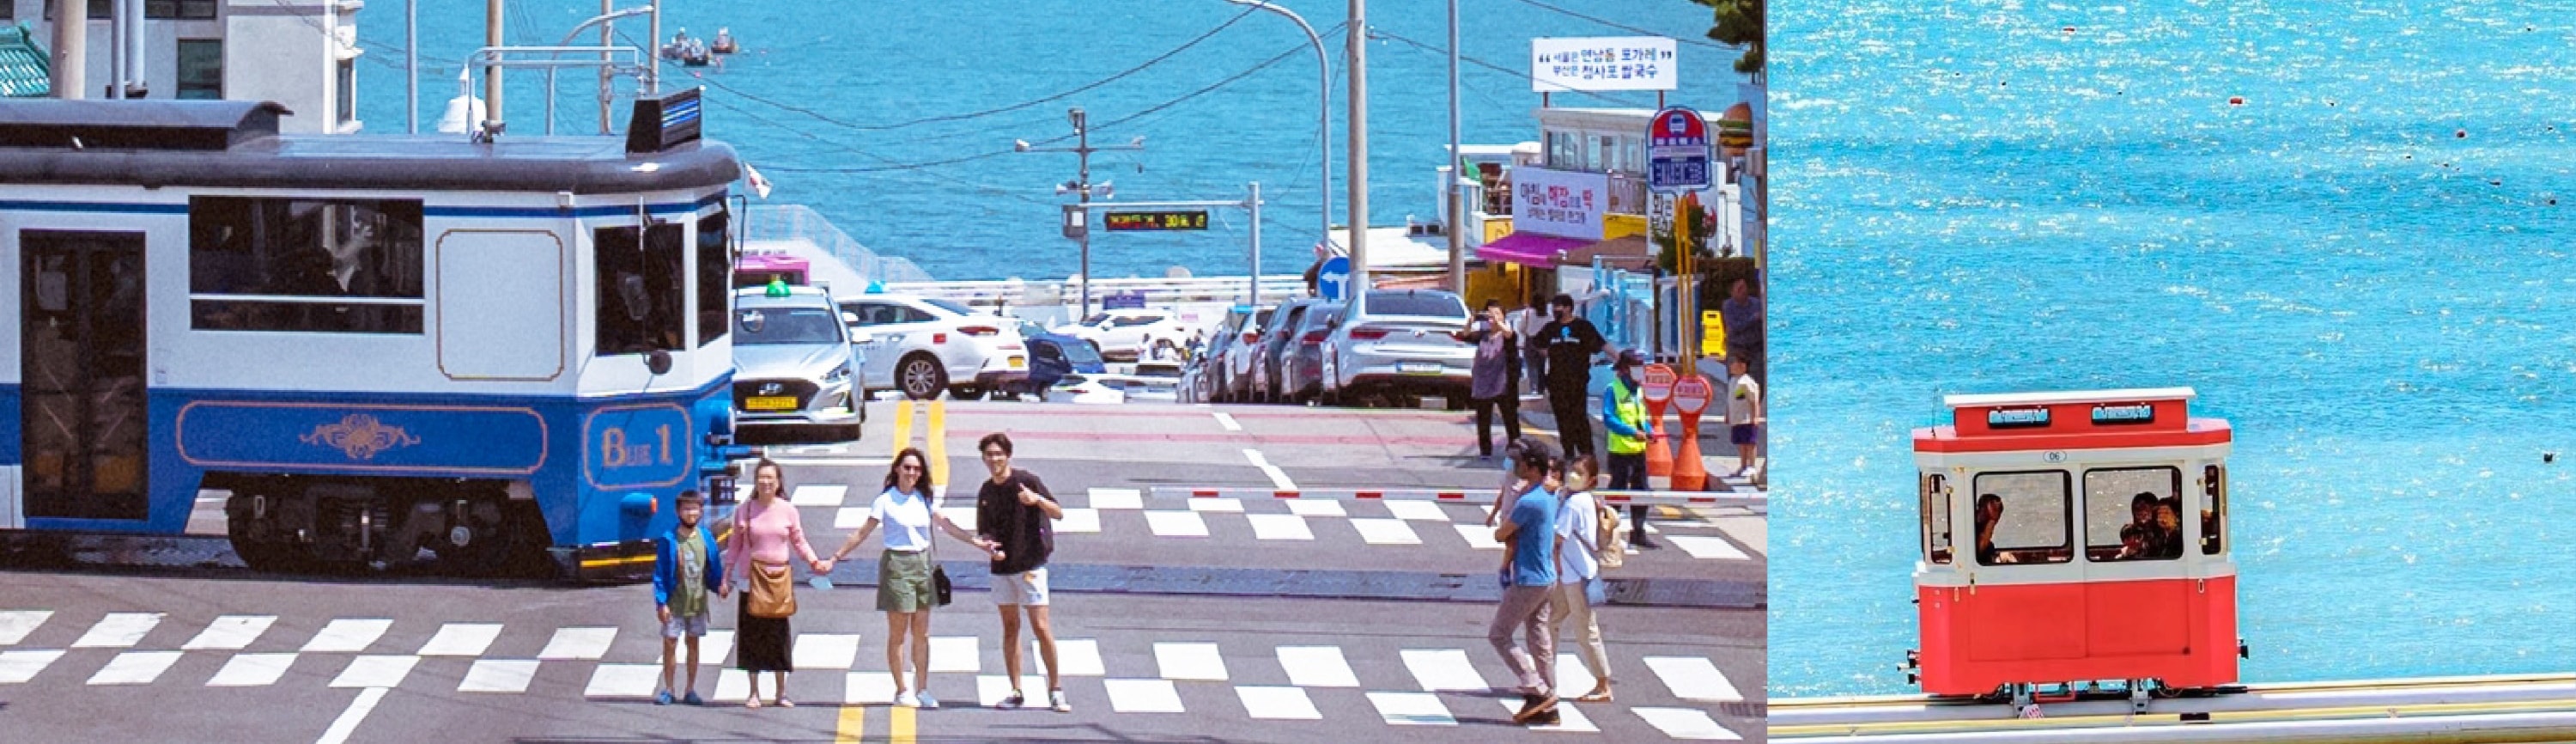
{"left": 1770, "top": 0, "right": 2576, "bottom": 698}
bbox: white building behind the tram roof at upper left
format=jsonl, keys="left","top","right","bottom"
{"left": 0, "top": 0, "right": 366, "bottom": 134}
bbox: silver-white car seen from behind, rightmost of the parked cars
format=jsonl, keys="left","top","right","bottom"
{"left": 1321, "top": 289, "right": 1476, "bottom": 409}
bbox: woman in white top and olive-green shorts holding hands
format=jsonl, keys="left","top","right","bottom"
{"left": 832, "top": 448, "right": 992, "bottom": 708}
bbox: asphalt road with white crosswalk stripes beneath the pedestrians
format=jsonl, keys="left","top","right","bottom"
{"left": 0, "top": 404, "right": 1767, "bottom": 741}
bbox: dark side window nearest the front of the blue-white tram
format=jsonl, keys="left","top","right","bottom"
{"left": 592, "top": 224, "right": 688, "bottom": 356}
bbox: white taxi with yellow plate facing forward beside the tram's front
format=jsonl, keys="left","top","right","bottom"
{"left": 734, "top": 286, "right": 868, "bottom": 442}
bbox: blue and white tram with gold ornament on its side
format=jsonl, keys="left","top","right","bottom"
{"left": 0, "top": 90, "right": 742, "bottom": 576}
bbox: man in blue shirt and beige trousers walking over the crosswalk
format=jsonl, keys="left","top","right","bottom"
{"left": 1484, "top": 437, "right": 1558, "bottom": 723}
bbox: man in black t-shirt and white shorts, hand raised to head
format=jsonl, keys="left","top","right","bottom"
{"left": 974, "top": 432, "right": 1074, "bottom": 713}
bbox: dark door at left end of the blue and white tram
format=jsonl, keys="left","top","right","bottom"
{"left": 18, "top": 229, "right": 149, "bottom": 520}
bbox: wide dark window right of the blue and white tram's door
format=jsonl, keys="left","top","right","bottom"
{"left": 188, "top": 196, "right": 425, "bottom": 335}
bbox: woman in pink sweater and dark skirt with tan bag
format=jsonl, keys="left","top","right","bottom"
{"left": 724, "top": 458, "right": 832, "bottom": 708}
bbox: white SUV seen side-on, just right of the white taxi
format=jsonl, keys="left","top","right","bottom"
{"left": 840, "top": 294, "right": 1028, "bottom": 399}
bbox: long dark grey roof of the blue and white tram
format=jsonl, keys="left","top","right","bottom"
{"left": 0, "top": 101, "right": 742, "bottom": 193}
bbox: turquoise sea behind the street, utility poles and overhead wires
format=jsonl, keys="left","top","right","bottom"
{"left": 358, "top": 0, "right": 1741, "bottom": 278}
